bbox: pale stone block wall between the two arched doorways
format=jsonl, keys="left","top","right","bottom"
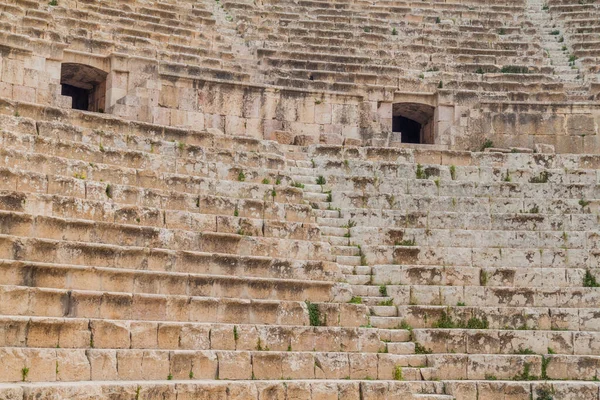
{"left": 112, "top": 74, "right": 370, "bottom": 144}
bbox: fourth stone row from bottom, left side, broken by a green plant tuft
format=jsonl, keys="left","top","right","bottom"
{"left": 0, "top": 286, "right": 366, "bottom": 327}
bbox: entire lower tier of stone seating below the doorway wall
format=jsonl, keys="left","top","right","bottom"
{"left": 0, "top": 101, "right": 600, "bottom": 399}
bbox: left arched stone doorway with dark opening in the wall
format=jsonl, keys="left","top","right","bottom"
{"left": 60, "top": 63, "right": 108, "bottom": 112}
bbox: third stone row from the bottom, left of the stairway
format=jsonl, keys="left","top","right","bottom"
{"left": 0, "top": 316, "right": 384, "bottom": 353}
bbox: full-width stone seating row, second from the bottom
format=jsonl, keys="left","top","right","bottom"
{"left": 0, "top": 342, "right": 600, "bottom": 382}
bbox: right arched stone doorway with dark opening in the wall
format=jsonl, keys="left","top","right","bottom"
{"left": 392, "top": 103, "right": 435, "bottom": 144}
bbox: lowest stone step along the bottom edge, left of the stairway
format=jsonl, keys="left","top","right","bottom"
{"left": 0, "top": 378, "right": 450, "bottom": 400}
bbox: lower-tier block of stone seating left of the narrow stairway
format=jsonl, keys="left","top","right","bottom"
{"left": 0, "top": 104, "right": 460, "bottom": 399}
